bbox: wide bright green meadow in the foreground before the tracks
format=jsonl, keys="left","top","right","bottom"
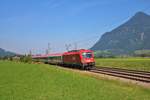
{"left": 0, "top": 61, "right": 150, "bottom": 100}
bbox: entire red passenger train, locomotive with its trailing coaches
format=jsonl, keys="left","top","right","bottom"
{"left": 32, "top": 49, "right": 95, "bottom": 69}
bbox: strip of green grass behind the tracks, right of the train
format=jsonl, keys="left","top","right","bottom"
{"left": 96, "top": 58, "right": 150, "bottom": 71}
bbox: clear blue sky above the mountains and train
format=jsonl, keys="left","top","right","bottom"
{"left": 0, "top": 0, "right": 150, "bottom": 53}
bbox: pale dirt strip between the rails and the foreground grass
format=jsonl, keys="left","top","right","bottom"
{"left": 57, "top": 67, "right": 150, "bottom": 88}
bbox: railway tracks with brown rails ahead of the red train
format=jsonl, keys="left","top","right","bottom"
{"left": 89, "top": 67, "right": 150, "bottom": 83}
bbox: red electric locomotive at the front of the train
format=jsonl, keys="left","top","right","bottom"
{"left": 63, "top": 49, "right": 95, "bottom": 69}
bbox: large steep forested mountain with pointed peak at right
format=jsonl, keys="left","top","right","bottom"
{"left": 91, "top": 12, "right": 150, "bottom": 54}
